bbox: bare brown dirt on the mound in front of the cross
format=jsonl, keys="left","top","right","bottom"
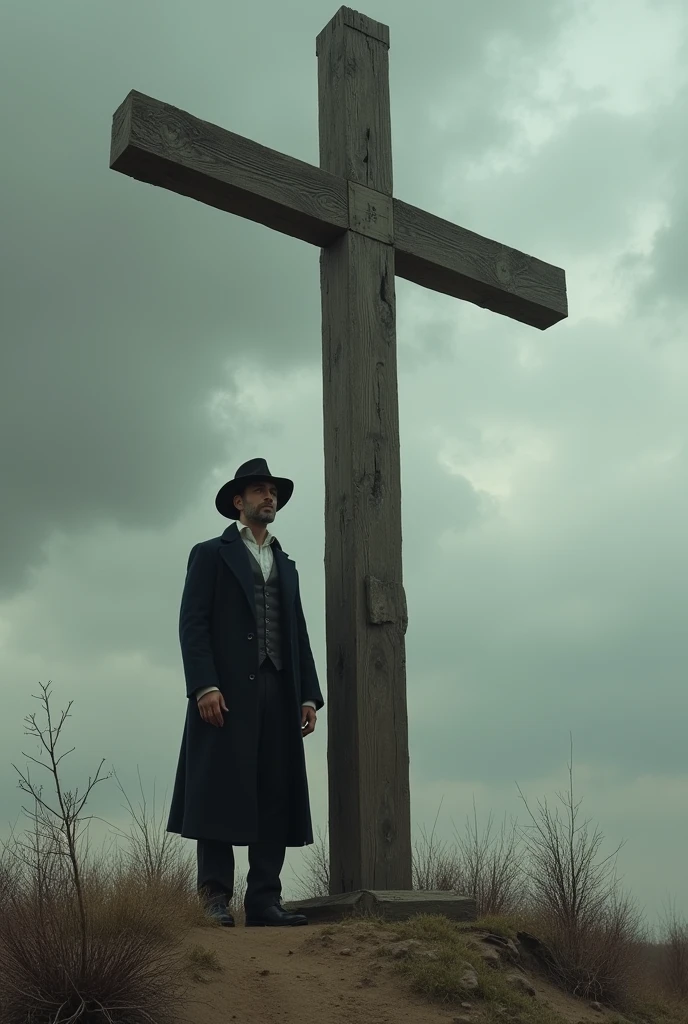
{"left": 180, "top": 926, "right": 605, "bottom": 1024}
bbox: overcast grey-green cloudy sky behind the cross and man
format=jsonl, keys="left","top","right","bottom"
{"left": 0, "top": 0, "right": 688, "bottom": 919}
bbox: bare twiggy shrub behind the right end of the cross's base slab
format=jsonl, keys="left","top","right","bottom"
{"left": 455, "top": 800, "right": 524, "bottom": 918}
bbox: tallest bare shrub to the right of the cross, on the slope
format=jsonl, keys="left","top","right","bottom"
{"left": 518, "top": 752, "right": 642, "bottom": 1005}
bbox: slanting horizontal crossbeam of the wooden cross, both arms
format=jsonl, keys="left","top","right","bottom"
{"left": 110, "top": 91, "right": 567, "bottom": 330}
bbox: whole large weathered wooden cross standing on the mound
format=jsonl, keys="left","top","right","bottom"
{"left": 111, "top": 7, "right": 567, "bottom": 894}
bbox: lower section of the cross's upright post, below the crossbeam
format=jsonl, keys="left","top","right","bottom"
{"left": 320, "top": 231, "right": 412, "bottom": 893}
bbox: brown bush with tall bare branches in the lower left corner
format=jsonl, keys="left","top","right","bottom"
{"left": 0, "top": 683, "right": 188, "bottom": 1024}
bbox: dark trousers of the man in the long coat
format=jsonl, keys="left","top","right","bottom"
{"left": 197, "top": 659, "right": 290, "bottom": 912}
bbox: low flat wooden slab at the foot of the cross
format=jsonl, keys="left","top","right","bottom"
{"left": 284, "top": 889, "right": 476, "bottom": 925}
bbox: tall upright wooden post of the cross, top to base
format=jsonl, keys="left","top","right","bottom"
{"left": 317, "top": 8, "right": 412, "bottom": 894}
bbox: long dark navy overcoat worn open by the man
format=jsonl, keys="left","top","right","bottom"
{"left": 167, "top": 523, "right": 324, "bottom": 846}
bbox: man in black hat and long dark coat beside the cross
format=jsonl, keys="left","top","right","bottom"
{"left": 167, "top": 459, "right": 324, "bottom": 927}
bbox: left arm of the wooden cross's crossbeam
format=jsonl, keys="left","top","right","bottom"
{"left": 110, "top": 92, "right": 348, "bottom": 246}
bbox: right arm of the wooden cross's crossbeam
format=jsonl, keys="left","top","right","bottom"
{"left": 394, "top": 200, "right": 568, "bottom": 330}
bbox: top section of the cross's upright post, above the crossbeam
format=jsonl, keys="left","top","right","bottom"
{"left": 317, "top": 11, "right": 392, "bottom": 196}
